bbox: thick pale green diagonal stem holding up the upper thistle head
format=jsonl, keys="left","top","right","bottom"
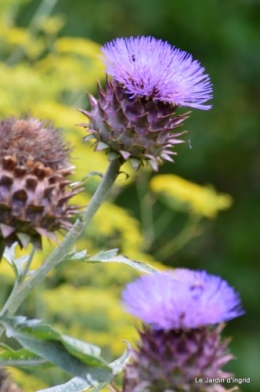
{"left": 0, "top": 160, "right": 120, "bottom": 316}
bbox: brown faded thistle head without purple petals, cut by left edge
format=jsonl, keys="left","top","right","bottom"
{"left": 0, "top": 118, "right": 80, "bottom": 248}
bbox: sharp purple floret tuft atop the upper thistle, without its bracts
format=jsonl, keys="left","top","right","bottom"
{"left": 101, "top": 37, "right": 212, "bottom": 110}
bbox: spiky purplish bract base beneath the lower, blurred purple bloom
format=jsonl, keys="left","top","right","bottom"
{"left": 123, "top": 325, "right": 233, "bottom": 392}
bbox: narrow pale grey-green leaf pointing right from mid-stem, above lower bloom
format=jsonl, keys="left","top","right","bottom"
{"left": 88, "top": 249, "right": 158, "bottom": 274}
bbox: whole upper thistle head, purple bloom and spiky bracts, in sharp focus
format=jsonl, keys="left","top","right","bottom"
{"left": 81, "top": 37, "right": 212, "bottom": 170}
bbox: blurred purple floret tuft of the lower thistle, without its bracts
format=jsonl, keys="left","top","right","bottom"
{"left": 122, "top": 269, "right": 243, "bottom": 330}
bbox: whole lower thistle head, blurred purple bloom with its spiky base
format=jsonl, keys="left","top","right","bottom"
{"left": 123, "top": 269, "right": 243, "bottom": 392}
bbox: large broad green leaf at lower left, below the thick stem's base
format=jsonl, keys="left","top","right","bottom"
{"left": 0, "top": 317, "right": 112, "bottom": 386}
